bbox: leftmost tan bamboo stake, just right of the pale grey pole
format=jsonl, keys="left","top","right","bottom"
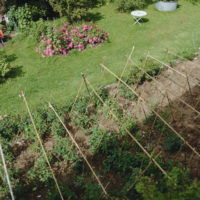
{"left": 21, "top": 93, "right": 64, "bottom": 200}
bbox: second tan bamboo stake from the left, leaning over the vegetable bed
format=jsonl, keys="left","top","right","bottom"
{"left": 49, "top": 103, "right": 108, "bottom": 196}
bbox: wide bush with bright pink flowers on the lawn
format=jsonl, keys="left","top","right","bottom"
{"left": 36, "top": 22, "right": 108, "bottom": 58}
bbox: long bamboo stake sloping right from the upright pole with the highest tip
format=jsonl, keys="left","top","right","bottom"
{"left": 131, "top": 60, "right": 200, "bottom": 119}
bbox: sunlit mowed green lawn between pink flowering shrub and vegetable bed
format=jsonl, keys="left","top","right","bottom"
{"left": 0, "top": 0, "right": 200, "bottom": 115}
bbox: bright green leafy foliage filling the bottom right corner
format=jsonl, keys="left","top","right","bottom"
{"left": 136, "top": 167, "right": 200, "bottom": 200}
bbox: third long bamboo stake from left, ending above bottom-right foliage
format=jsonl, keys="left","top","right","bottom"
{"left": 86, "top": 76, "right": 171, "bottom": 179}
